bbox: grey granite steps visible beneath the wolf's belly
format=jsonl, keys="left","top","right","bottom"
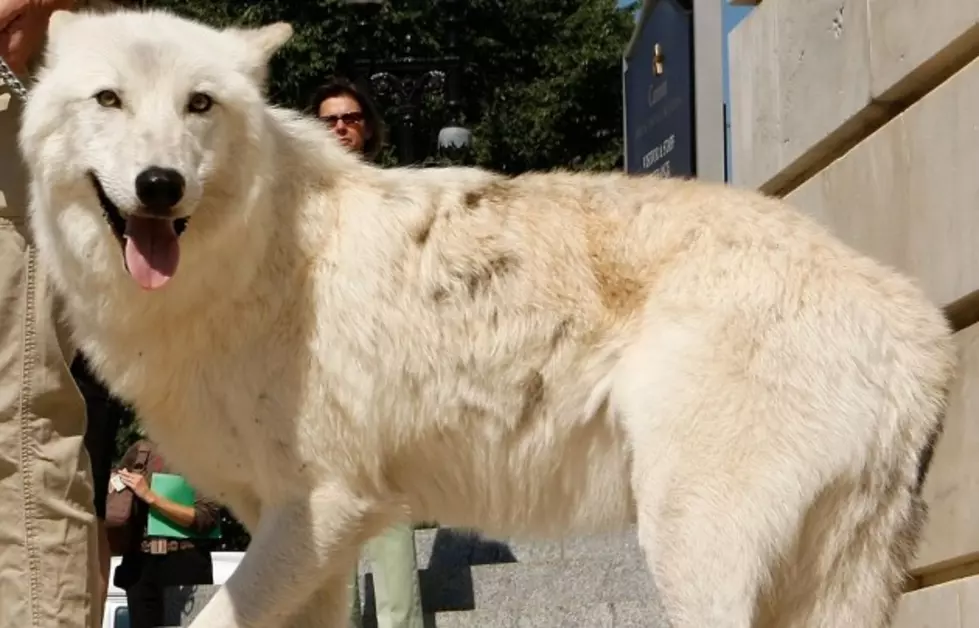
{"left": 166, "top": 528, "right": 665, "bottom": 628}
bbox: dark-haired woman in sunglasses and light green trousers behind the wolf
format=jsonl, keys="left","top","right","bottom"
{"left": 310, "top": 78, "right": 424, "bottom": 628}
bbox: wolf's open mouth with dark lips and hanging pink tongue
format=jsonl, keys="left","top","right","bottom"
{"left": 88, "top": 172, "right": 187, "bottom": 290}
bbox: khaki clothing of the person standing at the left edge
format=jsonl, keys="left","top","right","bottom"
{"left": 0, "top": 87, "right": 101, "bottom": 628}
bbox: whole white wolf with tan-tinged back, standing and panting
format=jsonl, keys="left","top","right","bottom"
{"left": 21, "top": 12, "right": 956, "bottom": 628}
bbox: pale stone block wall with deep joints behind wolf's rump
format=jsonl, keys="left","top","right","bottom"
{"left": 728, "top": 0, "right": 979, "bottom": 628}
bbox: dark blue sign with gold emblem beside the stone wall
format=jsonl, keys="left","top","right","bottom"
{"left": 623, "top": 0, "right": 696, "bottom": 177}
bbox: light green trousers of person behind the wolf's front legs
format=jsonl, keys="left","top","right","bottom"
{"left": 350, "top": 523, "right": 424, "bottom": 628}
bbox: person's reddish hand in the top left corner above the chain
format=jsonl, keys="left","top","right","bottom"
{"left": 0, "top": 0, "right": 74, "bottom": 75}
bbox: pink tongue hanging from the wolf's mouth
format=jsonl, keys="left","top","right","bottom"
{"left": 126, "top": 216, "right": 180, "bottom": 290}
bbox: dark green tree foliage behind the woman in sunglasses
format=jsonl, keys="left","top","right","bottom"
{"left": 145, "top": 0, "right": 633, "bottom": 173}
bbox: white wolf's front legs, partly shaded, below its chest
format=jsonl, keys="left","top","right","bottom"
{"left": 191, "top": 485, "right": 386, "bottom": 628}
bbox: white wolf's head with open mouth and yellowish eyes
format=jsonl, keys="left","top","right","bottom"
{"left": 20, "top": 12, "right": 292, "bottom": 289}
